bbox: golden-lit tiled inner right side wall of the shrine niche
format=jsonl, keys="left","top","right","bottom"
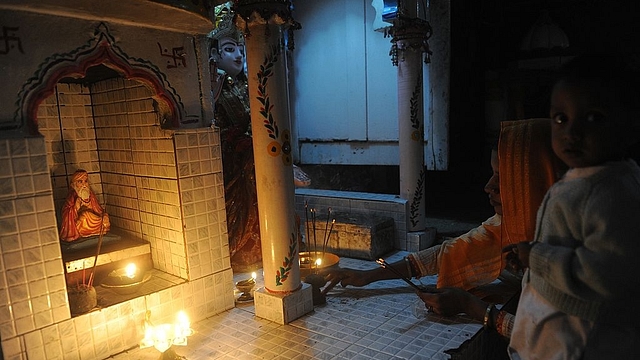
{"left": 91, "top": 78, "right": 170, "bottom": 245}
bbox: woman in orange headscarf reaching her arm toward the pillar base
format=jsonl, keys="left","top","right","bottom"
{"left": 325, "top": 119, "right": 564, "bottom": 290}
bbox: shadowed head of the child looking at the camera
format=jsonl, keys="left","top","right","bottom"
{"left": 550, "top": 81, "right": 628, "bottom": 168}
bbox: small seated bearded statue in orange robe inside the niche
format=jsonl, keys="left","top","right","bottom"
{"left": 60, "top": 170, "right": 111, "bottom": 242}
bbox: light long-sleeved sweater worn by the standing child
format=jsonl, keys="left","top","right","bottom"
{"left": 525, "top": 160, "right": 640, "bottom": 326}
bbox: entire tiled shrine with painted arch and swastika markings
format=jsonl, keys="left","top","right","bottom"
{"left": 0, "top": 0, "right": 233, "bottom": 359}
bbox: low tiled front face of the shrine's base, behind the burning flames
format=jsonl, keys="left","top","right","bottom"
{"left": 2, "top": 270, "right": 234, "bottom": 360}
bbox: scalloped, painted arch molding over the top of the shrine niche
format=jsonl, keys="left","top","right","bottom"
{"left": 14, "top": 23, "right": 184, "bottom": 135}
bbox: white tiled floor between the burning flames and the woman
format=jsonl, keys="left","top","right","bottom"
{"left": 110, "top": 252, "right": 481, "bottom": 360}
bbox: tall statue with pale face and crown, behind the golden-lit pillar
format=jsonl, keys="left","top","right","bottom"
{"left": 209, "top": 2, "right": 311, "bottom": 271}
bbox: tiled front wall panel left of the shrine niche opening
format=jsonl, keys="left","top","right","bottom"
{"left": 0, "top": 137, "right": 70, "bottom": 352}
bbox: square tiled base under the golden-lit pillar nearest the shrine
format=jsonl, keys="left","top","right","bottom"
{"left": 253, "top": 283, "right": 313, "bottom": 325}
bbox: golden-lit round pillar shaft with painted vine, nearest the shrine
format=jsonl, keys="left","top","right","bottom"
{"left": 235, "top": 0, "right": 301, "bottom": 294}
